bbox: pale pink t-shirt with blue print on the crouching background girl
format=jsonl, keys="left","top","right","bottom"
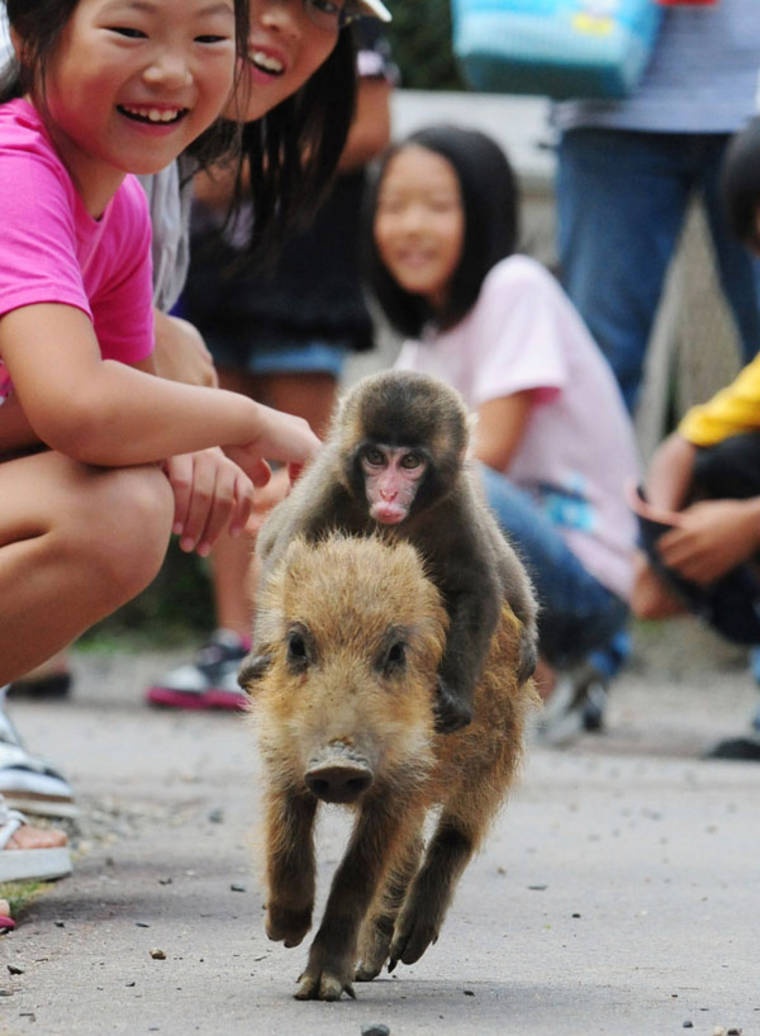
{"left": 396, "top": 255, "right": 639, "bottom": 598}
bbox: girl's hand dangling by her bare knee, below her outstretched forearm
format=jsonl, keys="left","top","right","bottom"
{"left": 165, "top": 447, "right": 255, "bottom": 557}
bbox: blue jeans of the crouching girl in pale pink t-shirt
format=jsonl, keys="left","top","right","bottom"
{"left": 480, "top": 465, "right": 629, "bottom": 668}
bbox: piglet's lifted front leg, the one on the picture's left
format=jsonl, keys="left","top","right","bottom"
{"left": 266, "top": 790, "right": 317, "bottom": 947}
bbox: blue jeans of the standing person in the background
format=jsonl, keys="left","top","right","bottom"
{"left": 557, "top": 128, "right": 760, "bottom": 412}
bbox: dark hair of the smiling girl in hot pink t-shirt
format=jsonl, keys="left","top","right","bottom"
{"left": 0, "top": 0, "right": 250, "bottom": 168}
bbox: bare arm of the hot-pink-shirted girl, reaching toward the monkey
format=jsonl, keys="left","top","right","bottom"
{"left": 0, "top": 305, "right": 319, "bottom": 474}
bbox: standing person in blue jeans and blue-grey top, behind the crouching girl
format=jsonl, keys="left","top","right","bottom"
{"left": 552, "top": 0, "right": 760, "bottom": 729}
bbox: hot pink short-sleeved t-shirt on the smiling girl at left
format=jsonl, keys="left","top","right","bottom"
{"left": 0, "top": 99, "right": 153, "bottom": 402}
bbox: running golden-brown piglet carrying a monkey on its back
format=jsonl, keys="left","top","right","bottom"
{"left": 241, "top": 536, "right": 535, "bottom": 1000}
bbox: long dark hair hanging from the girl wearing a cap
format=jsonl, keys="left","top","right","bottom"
{"left": 234, "top": 27, "right": 357, "bottom": 267}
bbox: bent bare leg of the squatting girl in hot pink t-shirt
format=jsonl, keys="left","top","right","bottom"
{"left": 0, "top": 452, "right": 174, "bottom": 685}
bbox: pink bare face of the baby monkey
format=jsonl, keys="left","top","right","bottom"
{"left": 358, "top": 442, "right": 428, "bottom": 525}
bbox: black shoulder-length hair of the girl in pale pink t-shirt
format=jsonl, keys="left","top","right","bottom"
{"left": 362, "top": 125, "right": 519, "bottom": 338}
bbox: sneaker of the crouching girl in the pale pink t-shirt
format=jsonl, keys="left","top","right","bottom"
{"left": 537, "top": 665, "right": 608, "bottom": 747}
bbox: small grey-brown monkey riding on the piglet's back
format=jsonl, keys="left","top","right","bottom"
{"left": 247, "top": 370, "right": 537, "bottom": 733}
